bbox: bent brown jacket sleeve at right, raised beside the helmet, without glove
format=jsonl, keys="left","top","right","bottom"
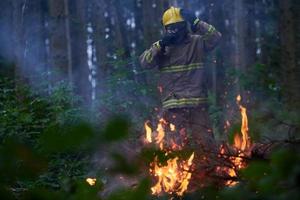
{"left": 194, "top": 20, "right": 222, "bottom": 51}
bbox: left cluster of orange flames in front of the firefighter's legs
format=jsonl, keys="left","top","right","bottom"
{"left": 145, "top": 119, "right": 194, "bottom": 196}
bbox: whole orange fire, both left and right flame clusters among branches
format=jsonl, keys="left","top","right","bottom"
{"left": 144, "top": 95, "right": 251, "bottom": 192}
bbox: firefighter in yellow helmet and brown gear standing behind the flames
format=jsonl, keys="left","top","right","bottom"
{"left": 140, "top": 7, "right": 221, "bottom": 151}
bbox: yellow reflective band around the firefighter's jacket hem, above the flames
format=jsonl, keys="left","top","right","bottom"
{"left": 163, "top": 98, "right": 207, "bottom": 108}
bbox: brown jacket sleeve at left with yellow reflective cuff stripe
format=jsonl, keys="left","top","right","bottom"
{"left": 140, "top": 41, "right": 163, "bottom": 69}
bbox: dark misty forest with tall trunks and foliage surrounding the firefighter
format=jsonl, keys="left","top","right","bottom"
{"left": 0, "top": 0, "right": 300, "bottom": 199}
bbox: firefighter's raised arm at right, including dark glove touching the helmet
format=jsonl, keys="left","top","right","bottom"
{"left": 180, "top": 9, "right": 222, "bottom": 51}
